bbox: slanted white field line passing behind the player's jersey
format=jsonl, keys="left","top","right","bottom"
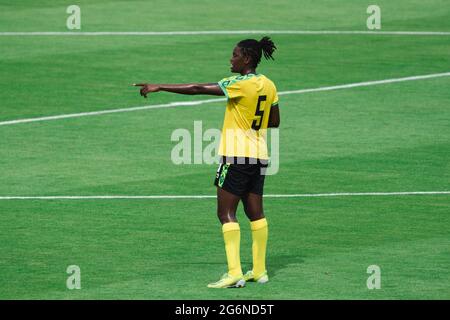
{"left": 0, "top": 72, "right": 450, "bottom": 126}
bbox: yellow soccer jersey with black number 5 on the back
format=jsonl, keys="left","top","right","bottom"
{"left": 219, "top": 73, "right": 278, "bottom": 160}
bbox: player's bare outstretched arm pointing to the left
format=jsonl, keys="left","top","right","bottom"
{"left": 134, "top": 83, "right": 225, "bottom": 98}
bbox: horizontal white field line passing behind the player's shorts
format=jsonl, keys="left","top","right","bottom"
{"left": 0, "top": 191, "right": 450, "bottom": 200}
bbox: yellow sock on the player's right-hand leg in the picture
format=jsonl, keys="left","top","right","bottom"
{"left": 250, "top": 218, "right": 269, "bottom": 277}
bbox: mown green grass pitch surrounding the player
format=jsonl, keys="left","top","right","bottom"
{"left": 0, "top": 0, "right": 450, "bottom": 299}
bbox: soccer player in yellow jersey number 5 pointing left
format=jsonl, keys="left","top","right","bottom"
{"left": 135, "top": 37, "right": 280, "bottom": 288}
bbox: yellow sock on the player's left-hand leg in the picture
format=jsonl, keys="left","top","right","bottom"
{"left": 222, "top": 222, "right": 242, "bottom": 277}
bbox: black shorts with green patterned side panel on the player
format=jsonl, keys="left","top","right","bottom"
{"left": 214, "top": 158, "right": 267, "bottom": 197}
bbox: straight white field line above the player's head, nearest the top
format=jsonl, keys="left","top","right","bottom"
{"left": 0, "top": 30, "right": 450, "bottom": 36}
